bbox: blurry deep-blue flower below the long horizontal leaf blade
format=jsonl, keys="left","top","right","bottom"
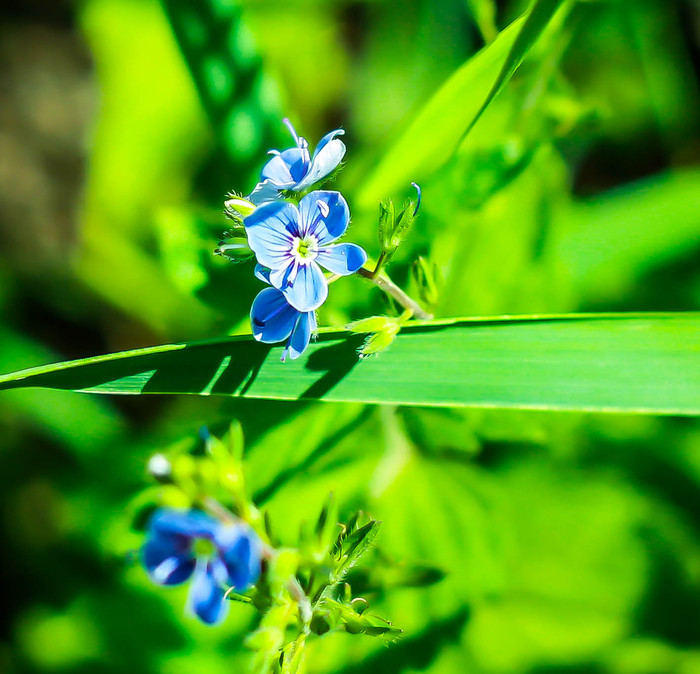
{"left": 141, "top": 509, "right": 261, "bottom": 625}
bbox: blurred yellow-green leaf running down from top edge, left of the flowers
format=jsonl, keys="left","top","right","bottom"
{"left": 77, "top": 0, "right": 219, "bottom": 336}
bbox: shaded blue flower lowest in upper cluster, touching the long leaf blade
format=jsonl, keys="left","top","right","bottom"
{"left": 250, "top": 265, "right": 316, "bottom": 361}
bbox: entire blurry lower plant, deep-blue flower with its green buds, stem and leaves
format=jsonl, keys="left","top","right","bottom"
{"left": 131, "top": 426, "right": 412, "bottom": 674}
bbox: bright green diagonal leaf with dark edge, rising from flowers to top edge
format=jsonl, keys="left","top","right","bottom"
{"left": 358, "top": 0, "right": 562, "bottom": 207}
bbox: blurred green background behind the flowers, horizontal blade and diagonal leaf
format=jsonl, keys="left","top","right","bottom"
{"left": 0, "top": 0, "right": 700, "bottom": 674}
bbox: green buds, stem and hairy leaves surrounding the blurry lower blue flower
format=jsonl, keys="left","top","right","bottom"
{"left": 137, "top": 422, "right": 401, "bottom": 674}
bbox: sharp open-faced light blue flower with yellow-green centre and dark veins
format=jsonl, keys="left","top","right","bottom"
{"left": 243, "top": 190, "right": 367, "bottom": 312}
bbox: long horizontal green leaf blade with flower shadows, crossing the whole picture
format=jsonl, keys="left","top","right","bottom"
{"left": 0, "top": 313, "right": 700, "bottom": 415}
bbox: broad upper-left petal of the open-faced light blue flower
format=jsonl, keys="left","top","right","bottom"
{"left": 243, "top": 201, "right": 299, "bottom": 269}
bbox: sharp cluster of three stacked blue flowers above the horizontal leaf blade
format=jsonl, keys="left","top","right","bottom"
{"left": 219, "top": 119, "right": 367, "bottom": 360}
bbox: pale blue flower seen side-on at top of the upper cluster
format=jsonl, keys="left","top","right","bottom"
{"left": 248, "top": 119, "right": 345, "bottom": 205}
